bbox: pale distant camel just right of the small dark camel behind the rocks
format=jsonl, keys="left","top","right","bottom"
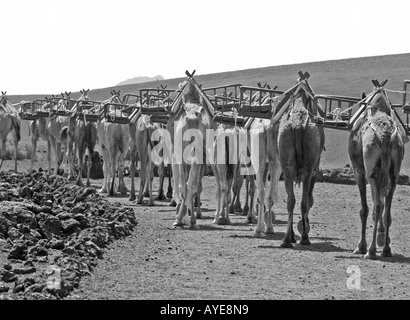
{"left": 97, "top": 91, "right": 130, "bottom": 196}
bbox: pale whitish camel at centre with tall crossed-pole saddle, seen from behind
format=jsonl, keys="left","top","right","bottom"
{"left": 171, "top": 76, "right": 215, "bottom": 229}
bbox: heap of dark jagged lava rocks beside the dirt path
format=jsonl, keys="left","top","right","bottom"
{"left": 0, "top": 170, "right": 137, "bottom": 300}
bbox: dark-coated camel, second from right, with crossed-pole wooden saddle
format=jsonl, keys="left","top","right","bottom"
{"left": 273, "top": 78, "right": 325, "bottom": 248}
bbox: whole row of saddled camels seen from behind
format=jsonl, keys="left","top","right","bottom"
{"left": 0, "top": 73, "right": 407, "bottom": 259}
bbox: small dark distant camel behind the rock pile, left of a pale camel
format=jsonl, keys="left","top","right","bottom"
{"left": 61, "top": 90, "right": 98, "bottom": 187}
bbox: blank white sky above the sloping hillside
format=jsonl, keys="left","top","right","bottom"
{"left": 0, "top": 0, "right": 410, "bottom": 95}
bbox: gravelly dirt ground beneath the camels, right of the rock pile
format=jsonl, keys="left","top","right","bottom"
{"left": 0, "top": 163, "right": 410, "bottom": 300}
